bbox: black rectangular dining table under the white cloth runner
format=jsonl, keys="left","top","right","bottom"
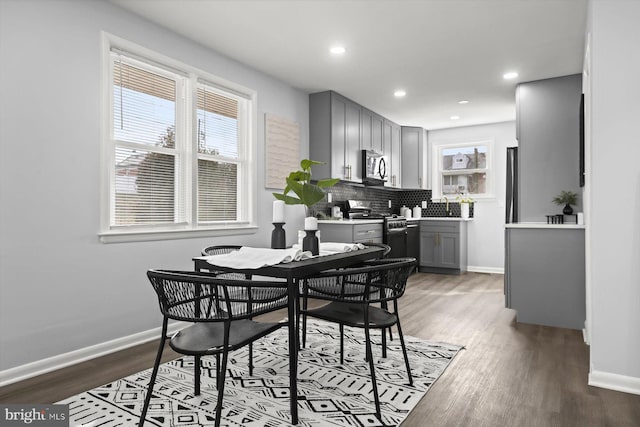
{"left": 193, "top": 246, "right": 384, "bottom": 424}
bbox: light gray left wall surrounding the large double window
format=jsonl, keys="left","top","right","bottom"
{"left": 0, "top": 0, "right": 309, "bottom": 371}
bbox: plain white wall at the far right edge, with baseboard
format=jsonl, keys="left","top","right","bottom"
{"left": 586, "top": 0, "right": 640, "bottom": 394}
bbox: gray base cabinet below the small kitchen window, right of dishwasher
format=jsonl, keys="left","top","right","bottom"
{"left": 419, "top": 220, "right": 467, "bottom": 274}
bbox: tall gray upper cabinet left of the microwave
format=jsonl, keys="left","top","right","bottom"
{"left": 309, "top": 91, "right": 363, "bottom": 182}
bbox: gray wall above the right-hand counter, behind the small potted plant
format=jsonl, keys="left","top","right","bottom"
{"left": 517, "top": 74, "right": 582, "bottom": 222}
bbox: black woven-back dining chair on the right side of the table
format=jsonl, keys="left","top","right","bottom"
{"left": 300, "top": 258, "right": 416, "bottom": 421}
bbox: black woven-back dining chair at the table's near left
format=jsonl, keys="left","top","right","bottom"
{"left": 138, "top": 270, "right": 288, "bottom": 427}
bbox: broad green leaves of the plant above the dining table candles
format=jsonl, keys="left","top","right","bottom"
{"left": 273, "top": 159, "right": 340, "bottom": 217}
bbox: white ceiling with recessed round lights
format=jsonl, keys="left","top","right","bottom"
{"left": 112, "top": 0, "right": 587, "bottom": 129}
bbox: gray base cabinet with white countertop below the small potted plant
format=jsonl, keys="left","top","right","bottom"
{"left": 504, "top": 224, "right": 586, "bottom": 330}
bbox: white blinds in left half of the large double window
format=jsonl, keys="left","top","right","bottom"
{"left": 111, "top": 53, "right": 185, "bottom": 226}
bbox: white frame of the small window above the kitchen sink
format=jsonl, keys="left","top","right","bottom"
{"left": 431, "top": 139, "right": 496, "bottom": 202}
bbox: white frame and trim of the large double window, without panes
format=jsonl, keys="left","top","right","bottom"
{"left": 98, "top": 32, "right": 258, "bottom": 243}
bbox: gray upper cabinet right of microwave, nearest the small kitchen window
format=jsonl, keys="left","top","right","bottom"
{"left": 400, "top": 126, "right": 426, "bottom": 188}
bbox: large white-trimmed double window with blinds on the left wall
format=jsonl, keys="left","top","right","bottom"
{"left": 101, "top": 35, "right": 255, "bottom": 241}
